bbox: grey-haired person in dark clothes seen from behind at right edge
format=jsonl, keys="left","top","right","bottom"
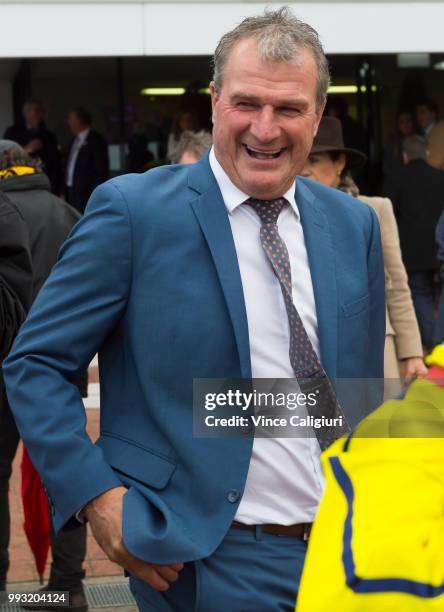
{"left": 383, "top": 135, "right": 444, "bottom": 350}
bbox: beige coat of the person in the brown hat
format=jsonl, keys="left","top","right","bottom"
{"left": 358, "top": 195, "right": 423, "bottom": 378}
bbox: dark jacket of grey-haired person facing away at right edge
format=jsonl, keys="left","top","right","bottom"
{"left": 383, "top": 159, "right": 444, "bottom": 272}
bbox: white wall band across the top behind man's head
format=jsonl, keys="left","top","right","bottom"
{"left": 0, "top": 0, "right": 444, "bottom": 58}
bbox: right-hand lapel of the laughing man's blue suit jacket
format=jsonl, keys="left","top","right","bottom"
{"left": 296, "top": 177, "right": 338, "bottom": 378}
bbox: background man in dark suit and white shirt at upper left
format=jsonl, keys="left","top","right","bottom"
{"left": 65, "top": 107, "right": 109, "bottom": 214}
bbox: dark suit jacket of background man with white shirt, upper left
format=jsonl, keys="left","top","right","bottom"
{"left": 66, "top": 129, "right": 109, "bottom": 214}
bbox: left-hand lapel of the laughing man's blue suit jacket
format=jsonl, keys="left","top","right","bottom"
{"left": 189, "top": 157, "right": 251, "bottom": 378}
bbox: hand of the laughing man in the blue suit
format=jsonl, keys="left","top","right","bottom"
{"left": 83, "top": 487, "right": 183, "bottom": 591}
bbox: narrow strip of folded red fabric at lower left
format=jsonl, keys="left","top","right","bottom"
{"left": 21, "top": 447, "right": 51, "bottom": 578}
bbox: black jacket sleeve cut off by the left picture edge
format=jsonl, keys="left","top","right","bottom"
{"left": 0, "top": 192, "right": 32, "bottom": 361}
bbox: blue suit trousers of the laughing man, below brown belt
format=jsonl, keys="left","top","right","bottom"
{"left": 130, "top": 527, "right": 307, "bottom": 612}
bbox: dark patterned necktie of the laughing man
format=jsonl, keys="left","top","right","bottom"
{"left": 245, "top": 198, "right": 350, "bottom": 450}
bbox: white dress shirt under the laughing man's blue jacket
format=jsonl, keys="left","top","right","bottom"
{"left": 210, "top": 149, "right": 324, "bottom": 525}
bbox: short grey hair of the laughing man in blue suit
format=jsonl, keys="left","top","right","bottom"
{"left": 213, "top": 6, "right": 330, "bottom": 110}
